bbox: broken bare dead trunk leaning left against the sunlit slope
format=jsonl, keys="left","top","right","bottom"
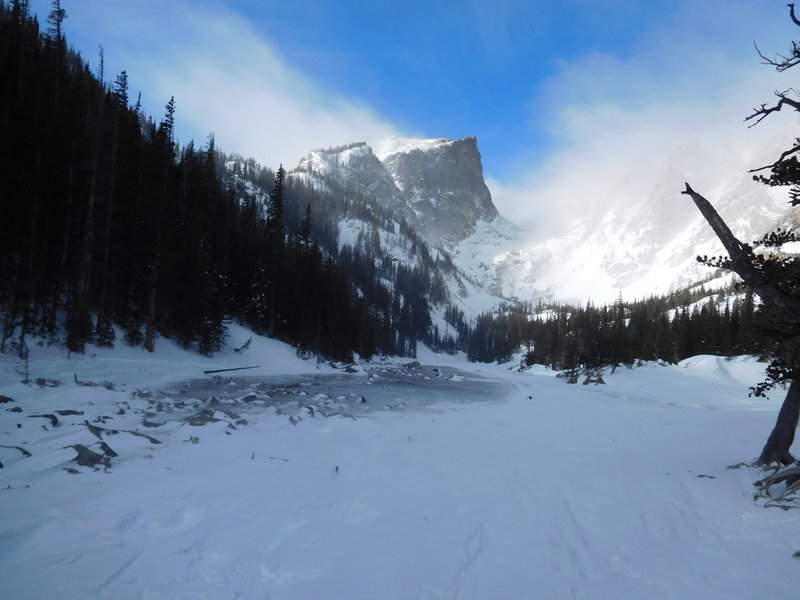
{"left": 681, "top": 183, "right": 800, "bottom": 322}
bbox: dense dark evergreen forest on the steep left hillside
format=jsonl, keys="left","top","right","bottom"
{"left": 0, "top": 0, "right": 384, "bottom": 359}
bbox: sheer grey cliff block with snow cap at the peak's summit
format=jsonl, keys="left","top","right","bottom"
{"left": 379, "top": 137, "right": 497, "bottom": 243}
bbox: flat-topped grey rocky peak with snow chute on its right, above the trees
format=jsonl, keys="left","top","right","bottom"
{"left": 289, "top": 137, "right": 523, "bottom": 308}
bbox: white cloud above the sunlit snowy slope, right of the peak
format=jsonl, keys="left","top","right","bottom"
{"left": 490, "top": 4, "right": 797, "bottom": 241}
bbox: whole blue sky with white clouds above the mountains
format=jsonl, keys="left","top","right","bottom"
{"left": 25, "top": 0, "right": 797, "bottom": 231}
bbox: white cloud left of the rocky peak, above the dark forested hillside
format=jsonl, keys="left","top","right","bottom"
{"left": 46, "top": 0, "right": 397, "bottom": 168}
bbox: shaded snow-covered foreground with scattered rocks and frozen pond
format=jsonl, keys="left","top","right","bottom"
{"left": 0, "top": 327, "right": 800, "bottom": 600}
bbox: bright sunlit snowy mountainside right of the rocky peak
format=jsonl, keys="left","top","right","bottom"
{"left": 510, "top": 133, "right": 797, "bottom": 302}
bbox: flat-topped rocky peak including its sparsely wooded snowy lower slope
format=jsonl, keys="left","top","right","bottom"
{"left": 289, "top": 137, "right": 521, "bottom": 319}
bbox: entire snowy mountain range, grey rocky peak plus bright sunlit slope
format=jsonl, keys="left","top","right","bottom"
{"left": 255, "top": 132, "right": 794, "bottom": 317}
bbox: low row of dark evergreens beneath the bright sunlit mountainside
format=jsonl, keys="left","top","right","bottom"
{"left": 467, "top": 290, "right": 767, "bottom": 370}
